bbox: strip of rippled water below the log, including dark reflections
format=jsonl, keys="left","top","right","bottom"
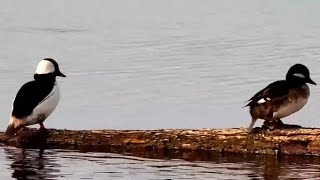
{"left": 0, "top": 147, "right": 320, "bottom": 180}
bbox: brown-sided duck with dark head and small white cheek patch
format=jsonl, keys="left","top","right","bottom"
{"left": 246, "top": 64, "right": 316, "bottom": 132}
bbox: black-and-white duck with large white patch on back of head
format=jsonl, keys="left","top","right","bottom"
{"left": 5, "top": 58, "right": 66, "bottom": 137}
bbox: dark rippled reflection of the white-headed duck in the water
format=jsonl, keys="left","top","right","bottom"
{"left": 5, "top": 148, "right": 60, "bottom": 179}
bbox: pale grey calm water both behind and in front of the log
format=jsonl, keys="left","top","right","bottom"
{"left": 0, "top": 0, "right": 320, "bottom": 179}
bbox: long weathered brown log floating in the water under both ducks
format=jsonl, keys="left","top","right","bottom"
{"left": 0, "top": 128, "right": 320, "bottom": 156}
